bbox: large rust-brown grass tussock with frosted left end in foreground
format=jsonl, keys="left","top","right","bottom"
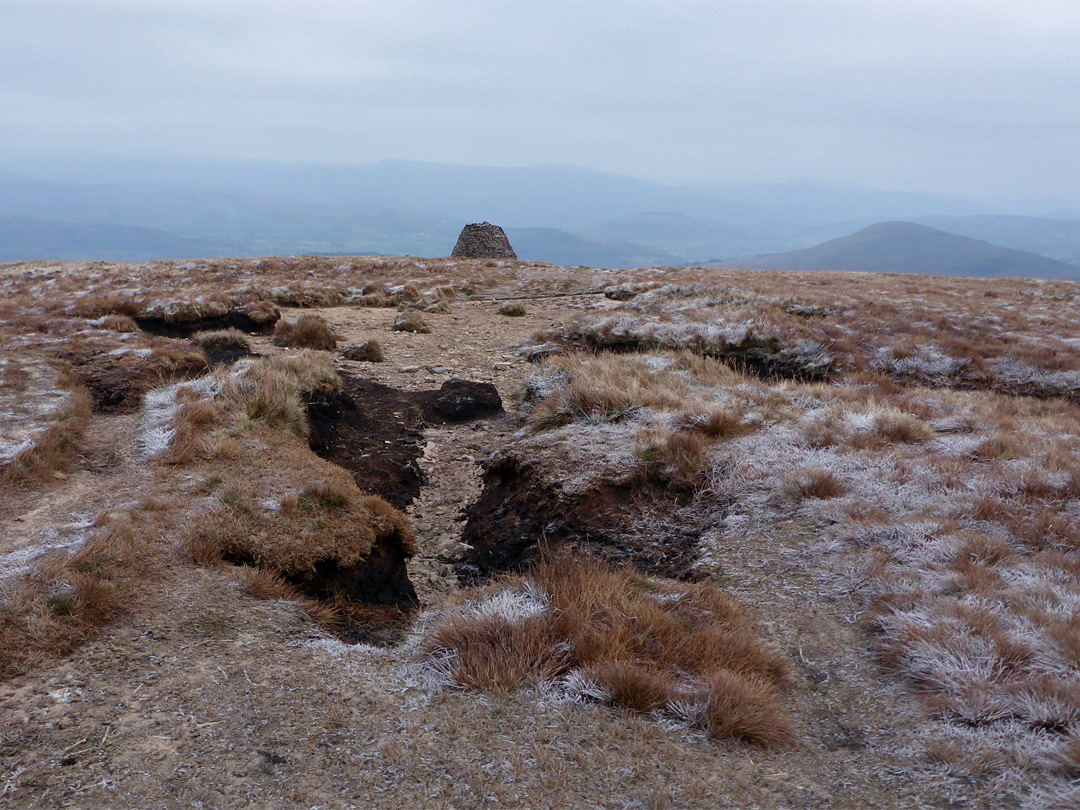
{"left": 422, "top": 554, "right": 794, "bottom": 744}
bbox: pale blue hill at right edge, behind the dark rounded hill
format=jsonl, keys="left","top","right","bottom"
{"left": 913, "top": 214, "right": 1080, "bottom": 265}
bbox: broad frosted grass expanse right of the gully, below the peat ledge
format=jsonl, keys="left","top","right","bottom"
{"left": 507, "top": 343, "right": 1080, "bottom": 799}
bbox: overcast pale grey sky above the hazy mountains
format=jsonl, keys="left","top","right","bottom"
{"left": 0, "top": 0, "right": 1080, "bottom": 201}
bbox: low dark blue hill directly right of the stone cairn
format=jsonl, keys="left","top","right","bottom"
{"left": 507, "top": 228, "right": 684, "bottom": 269}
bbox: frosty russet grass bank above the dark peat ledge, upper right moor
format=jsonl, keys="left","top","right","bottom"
{"left": 535, "top": 271, "right": 1080, "bottom": 397}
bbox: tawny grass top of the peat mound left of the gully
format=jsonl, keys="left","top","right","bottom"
{"left": 159, "top": 352, "right": 415, "bottom": 576}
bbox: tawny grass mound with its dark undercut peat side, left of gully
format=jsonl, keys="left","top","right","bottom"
{"left": 173, "top": 367, "right": 417, "bottom": 632}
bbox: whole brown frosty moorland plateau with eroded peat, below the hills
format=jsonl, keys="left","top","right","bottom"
{"left": 0, "top": 256, "right": 1080, "bottom": 808}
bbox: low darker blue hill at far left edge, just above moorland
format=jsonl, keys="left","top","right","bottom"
{"left": 0, "top": 217, "right": 229, "bottom": 261}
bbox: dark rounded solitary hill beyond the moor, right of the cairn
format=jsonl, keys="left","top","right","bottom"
{"left": 715, "top": 222, "right": 1080, "bottom": 279}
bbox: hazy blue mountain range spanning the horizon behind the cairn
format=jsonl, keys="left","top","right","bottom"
{"left": 0, "top": 152, "right": 1080, "bottom": 272}
